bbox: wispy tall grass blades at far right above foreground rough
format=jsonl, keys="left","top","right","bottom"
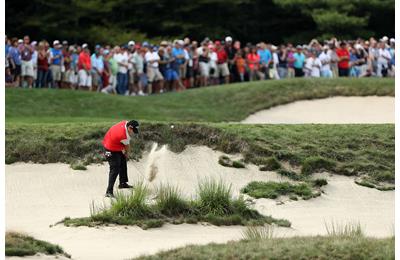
{"left": 325, "top": 221, "right": 364, "bottom": 238}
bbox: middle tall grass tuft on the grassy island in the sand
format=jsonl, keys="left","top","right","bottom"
{"left": 156, "top": 184, "right": 190, "bottom": 216}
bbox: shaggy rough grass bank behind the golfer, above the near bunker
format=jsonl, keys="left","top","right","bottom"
{"left": 6, "top": 123, "right": 395, "bottom": 187}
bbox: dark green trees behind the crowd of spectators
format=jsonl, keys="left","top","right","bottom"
{"left": 5, "top": 0, "right": 395, "bottom": 44}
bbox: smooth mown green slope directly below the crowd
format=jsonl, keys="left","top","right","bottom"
{"left": 5, "top": 78, "right": 395, "bottom": 123}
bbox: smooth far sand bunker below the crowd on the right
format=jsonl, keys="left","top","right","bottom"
{"left": 242, "top": 96, "right": 395, "bottom": 124}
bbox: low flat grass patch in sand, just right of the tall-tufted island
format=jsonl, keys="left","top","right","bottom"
{"left": 241, "top": 181, "right": 314, "bottom": 199}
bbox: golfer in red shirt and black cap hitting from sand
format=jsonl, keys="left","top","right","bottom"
{"left": 103, "top": 120, "right": 139, "bottom": 198}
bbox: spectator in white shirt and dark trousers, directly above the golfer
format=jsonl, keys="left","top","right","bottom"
{"left": 114, "top": 46, "right": 129, "bottom": 95}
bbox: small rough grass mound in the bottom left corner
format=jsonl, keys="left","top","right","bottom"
{"left": 5, "top": 232, "right": 71, "bottom": 258}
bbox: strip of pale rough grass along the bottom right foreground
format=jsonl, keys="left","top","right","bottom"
{"left": 135, "top": 236, "right": 395, "bottom": 260}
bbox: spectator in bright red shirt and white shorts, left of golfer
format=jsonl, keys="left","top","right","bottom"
{"left": 78, "top": 43, "right": 92, "bottom": 90}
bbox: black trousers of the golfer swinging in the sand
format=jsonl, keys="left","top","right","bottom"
{"left": 106, "top": 152, "right": 128, "bottom": 193}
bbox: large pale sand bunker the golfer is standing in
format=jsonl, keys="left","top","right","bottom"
{"left": 6, "top": 147, "right": 394, "bottom": 259}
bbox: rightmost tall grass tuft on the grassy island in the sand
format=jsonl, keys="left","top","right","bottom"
{"left": 197, "top": 179, "right": 232, "bottom": 216}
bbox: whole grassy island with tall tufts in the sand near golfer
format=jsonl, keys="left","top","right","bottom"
{"left": 63, "top": 180, "right": 290, "bottom": 229}
